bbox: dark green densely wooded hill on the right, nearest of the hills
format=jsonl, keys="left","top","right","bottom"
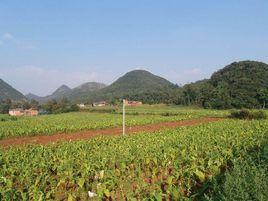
{"left": 183, "top": 61, "right": 268, "bottom": 109}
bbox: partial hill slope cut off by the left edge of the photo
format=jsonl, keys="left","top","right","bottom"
{"left": 0, "top": 79, "right": 26, "bottom": 100}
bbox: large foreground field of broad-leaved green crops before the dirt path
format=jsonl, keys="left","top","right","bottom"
{"left": 0, "top": 120, "right": 268, "bottom": 201}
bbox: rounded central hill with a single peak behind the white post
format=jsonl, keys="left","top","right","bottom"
{"left": 69, "top": 70, "right": 175, "bottom": 103}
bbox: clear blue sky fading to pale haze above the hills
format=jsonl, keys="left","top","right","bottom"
{"left": 0, "top": 0, "right": 268, "bottom": 96}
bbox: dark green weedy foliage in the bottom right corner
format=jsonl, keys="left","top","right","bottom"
{"left": 203, "top": 141, "right": 268, "bottom": 201}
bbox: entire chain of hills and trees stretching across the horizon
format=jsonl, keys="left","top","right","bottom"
{"left": 6, "top": 61, "right": 268, "bottom": 109}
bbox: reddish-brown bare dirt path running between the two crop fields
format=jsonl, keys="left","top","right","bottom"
{"left": 0, "top": 117, "right": 222, "bottom": 148}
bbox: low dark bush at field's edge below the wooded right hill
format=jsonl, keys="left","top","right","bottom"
{"left": 229, "top": 109, "right": 267, "bottom": 119}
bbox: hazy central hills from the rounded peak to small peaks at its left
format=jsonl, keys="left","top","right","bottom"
{"left": 27, "top": 70, "right": 175, "bottom": 103}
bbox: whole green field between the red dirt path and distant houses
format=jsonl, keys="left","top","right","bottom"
{"left": 0, "top": 105, "right": 226, "bottom": 139}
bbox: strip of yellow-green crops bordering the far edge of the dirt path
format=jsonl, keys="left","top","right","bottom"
{"left": 0, "top": 107, "right": 226, "bottom": 139}
